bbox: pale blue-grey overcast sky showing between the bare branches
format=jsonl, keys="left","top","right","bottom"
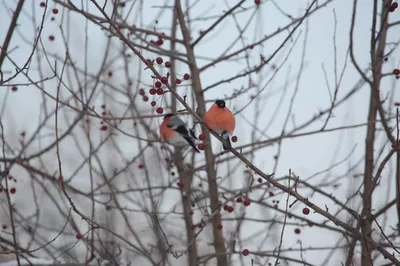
{"left": 0, "top": 0, "right": 400, "bottom": 265}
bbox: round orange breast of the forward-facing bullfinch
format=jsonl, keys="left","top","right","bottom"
{"left": 204, "top": 103, "right": 235, "bottom": 134}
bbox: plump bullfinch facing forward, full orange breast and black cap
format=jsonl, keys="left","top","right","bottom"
{"left": 204, "top": 100, "right": 235, "bottom": 150}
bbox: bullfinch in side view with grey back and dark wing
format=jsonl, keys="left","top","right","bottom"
{"left": 160, "top": 114, "right": 200, "bottom": 152}
